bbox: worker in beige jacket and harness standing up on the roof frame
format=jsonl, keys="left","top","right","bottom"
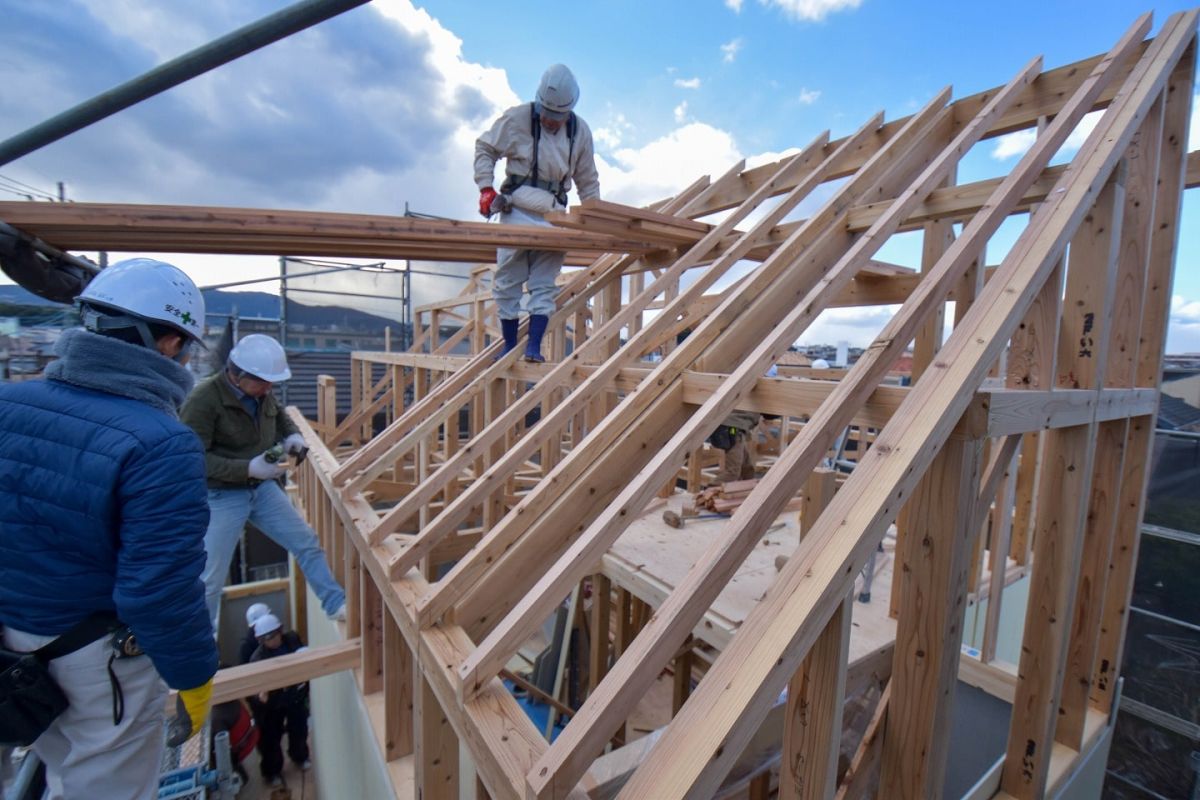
{"left": 475, "top": 64, "right": 600, "bottom": 362}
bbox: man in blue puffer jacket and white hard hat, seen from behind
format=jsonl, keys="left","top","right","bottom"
{"left": 0, "top": 259, "right": 217, "bottom": 798}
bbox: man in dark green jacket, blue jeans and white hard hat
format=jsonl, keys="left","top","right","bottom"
{"left": 180, "top": 333, "right": 346, "bottom": 630}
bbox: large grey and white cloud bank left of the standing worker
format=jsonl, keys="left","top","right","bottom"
{"left": 0, "top": 0, "right": 520, "bottom": 218}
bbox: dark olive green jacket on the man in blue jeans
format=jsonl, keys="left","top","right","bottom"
{"left": 179, "top": 369, "right": 296, "bottom": 489}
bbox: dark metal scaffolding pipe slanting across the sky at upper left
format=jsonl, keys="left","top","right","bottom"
{"left": 0, "top": 0, "right": 370, "bottom": 167}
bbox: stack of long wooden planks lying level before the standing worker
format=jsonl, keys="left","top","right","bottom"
{"left": 0, "top": 201, "right": 656, "bottom": 264}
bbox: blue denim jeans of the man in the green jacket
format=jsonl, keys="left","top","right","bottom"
{"left": 204, "top": 481, "right": 346, "bottom": 631}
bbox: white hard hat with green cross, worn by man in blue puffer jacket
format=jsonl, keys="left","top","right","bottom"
{"left": 76, "top": 258, "right": 204, "bottom": 342}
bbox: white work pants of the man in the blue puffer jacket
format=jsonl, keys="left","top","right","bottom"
{"left": 4, "top": 628, "right": 167, "bottom": 800}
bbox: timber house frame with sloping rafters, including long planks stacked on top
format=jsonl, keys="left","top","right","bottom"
{"left": 0, "top": 11, "right": 1196, "bottom": 799}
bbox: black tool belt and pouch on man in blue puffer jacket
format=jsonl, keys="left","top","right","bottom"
{"left": 0, "top": 612, "right": 121, "bottom": 747}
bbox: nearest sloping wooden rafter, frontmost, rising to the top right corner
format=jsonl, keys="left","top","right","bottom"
{"left": 628, "top": 10, "right": 1194, "bottom": 798}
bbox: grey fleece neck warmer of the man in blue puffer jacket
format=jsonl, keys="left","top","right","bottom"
{"left": 46, "top": 327, "right": 196, "bottom": 416}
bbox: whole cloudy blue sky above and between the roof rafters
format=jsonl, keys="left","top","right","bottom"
{"left": 0, "top": 0, "right": 1200, "bottom": 351}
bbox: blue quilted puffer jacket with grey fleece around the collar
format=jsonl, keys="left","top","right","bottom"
{"left": 0, "top": 330, "right": 217, "bottom": 688}
